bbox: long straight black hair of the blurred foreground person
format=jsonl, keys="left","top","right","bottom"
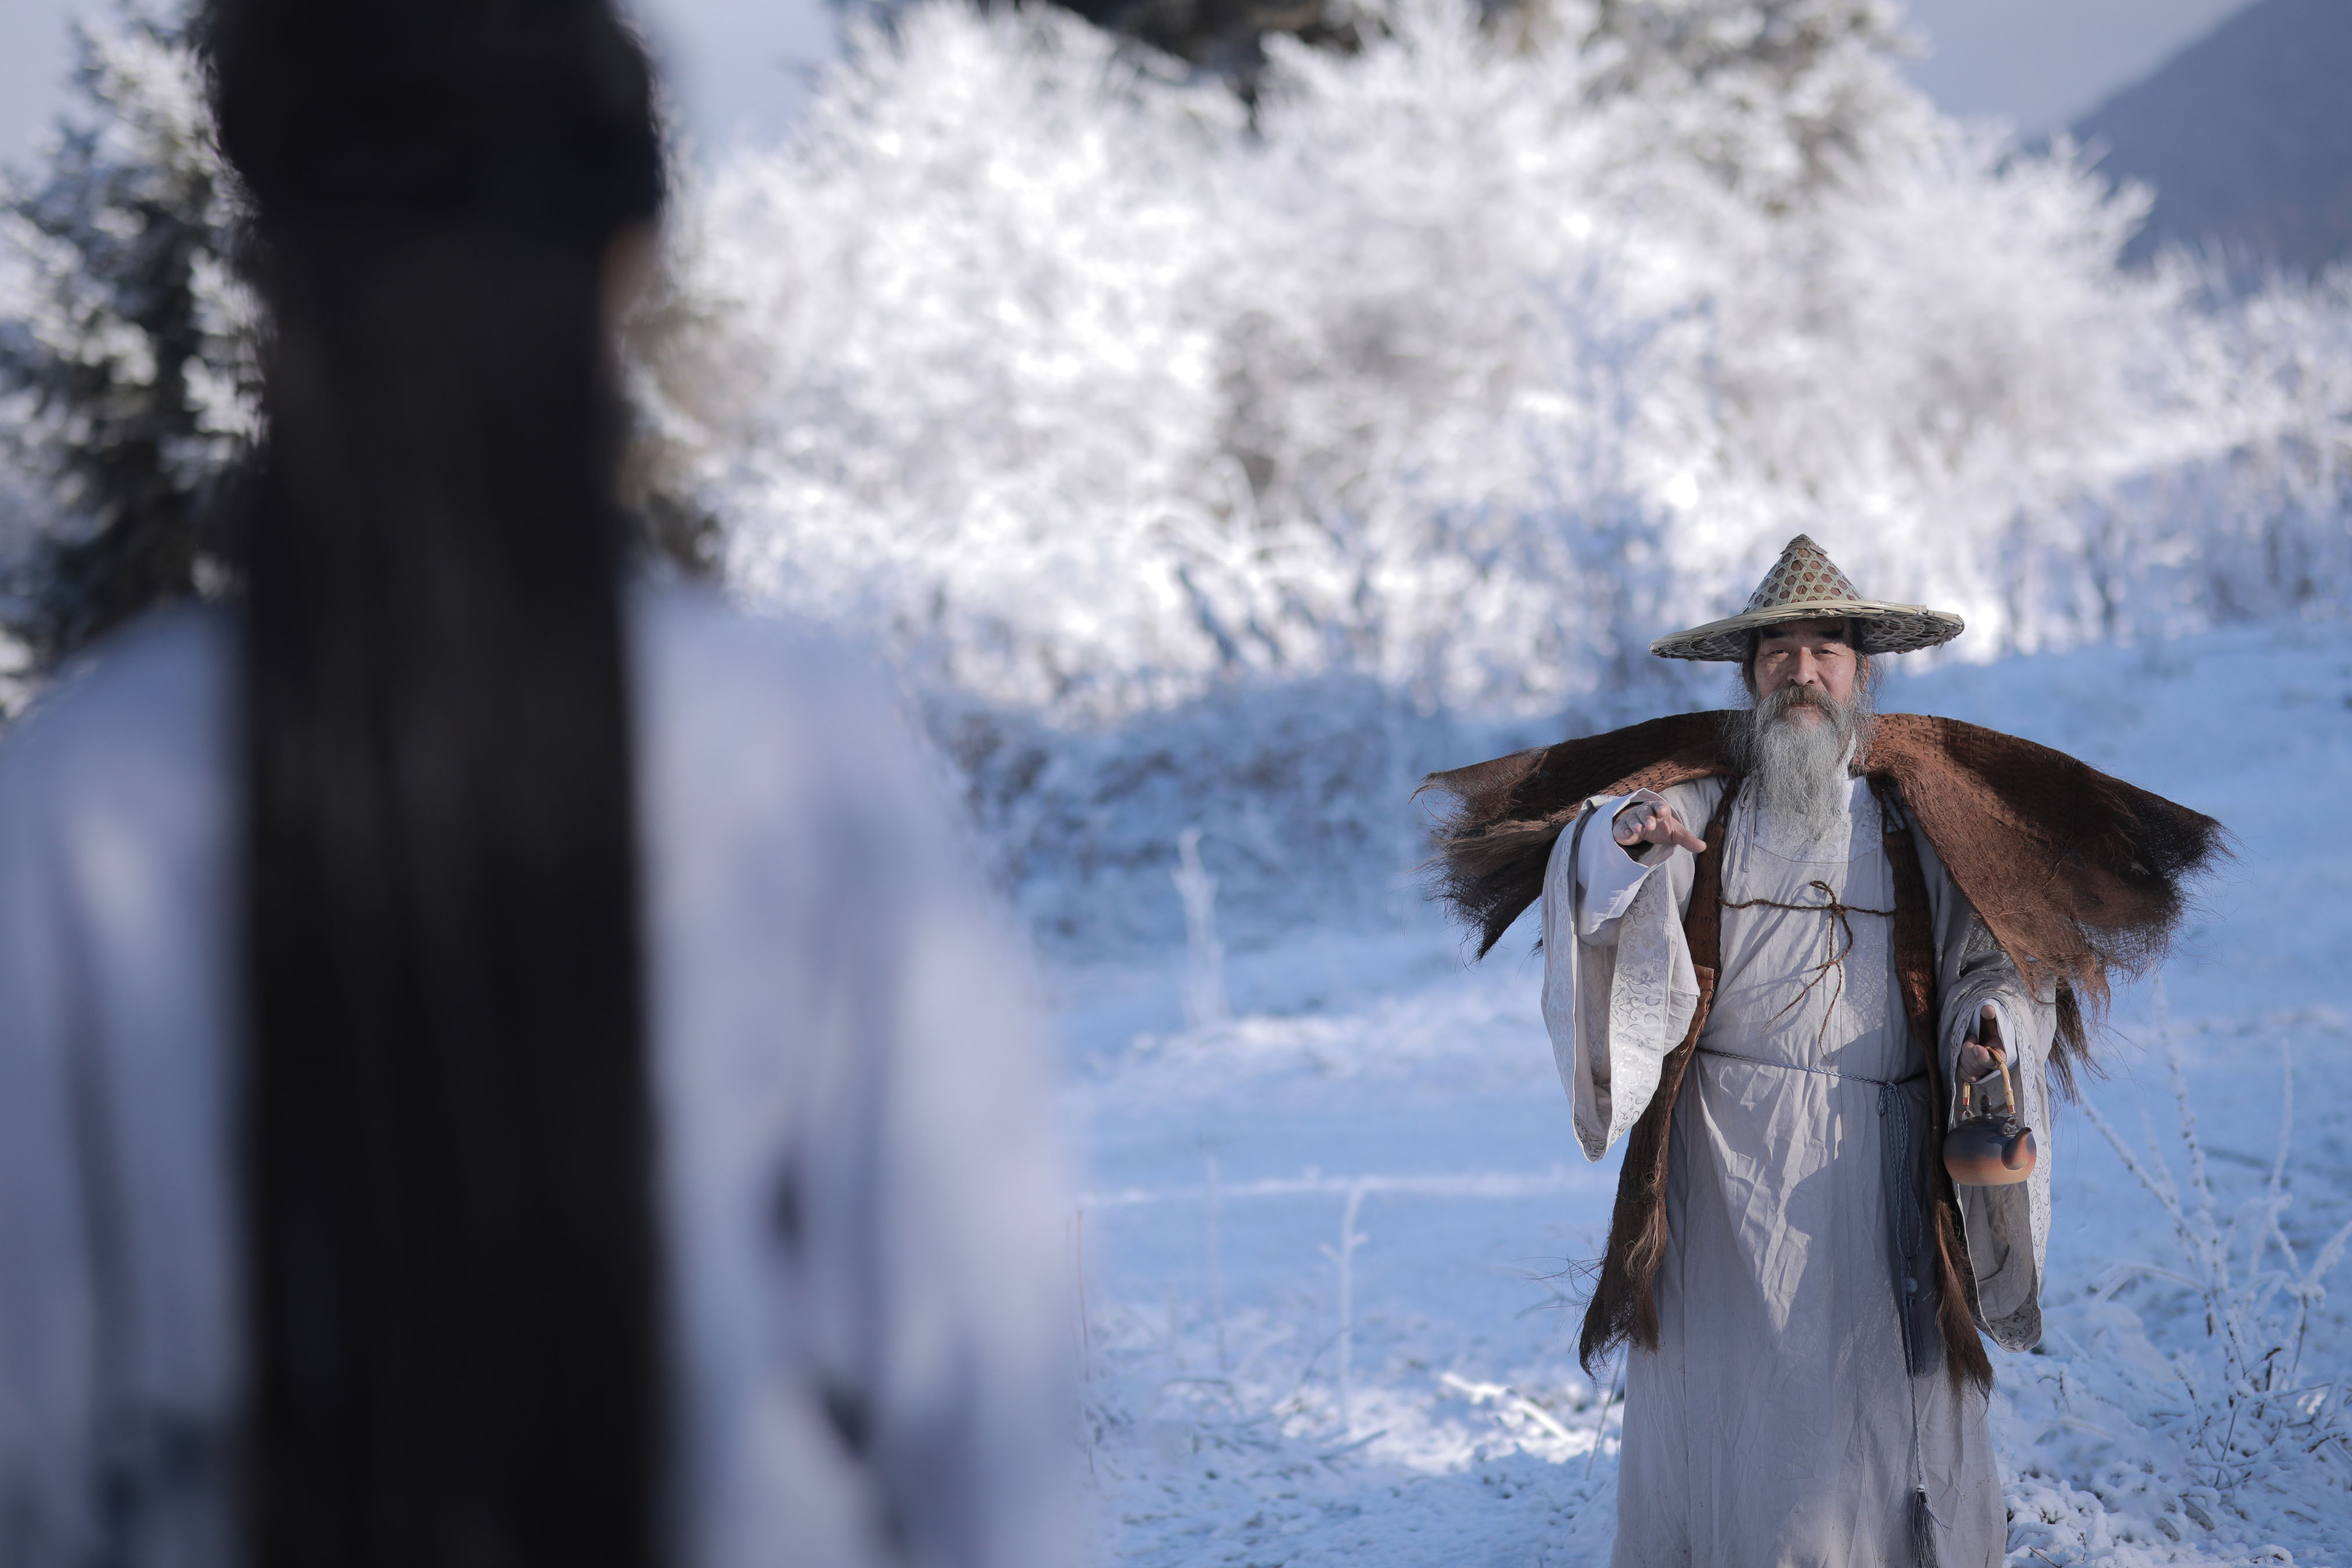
{"left": 202, "top": 0, "right": 663, "bottom": 1568}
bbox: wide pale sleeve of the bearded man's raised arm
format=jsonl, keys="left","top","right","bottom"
{"left": 1543, "top": 785, "right": 1720, "bottom": 1159}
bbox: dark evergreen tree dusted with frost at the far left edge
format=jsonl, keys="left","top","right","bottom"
{"left": 0, "top": 14, "right": 259, "bottom": 658}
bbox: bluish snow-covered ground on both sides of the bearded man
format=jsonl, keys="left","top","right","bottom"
{"left": 1056, "top": 623, "right": 2352, "bottom": 1568}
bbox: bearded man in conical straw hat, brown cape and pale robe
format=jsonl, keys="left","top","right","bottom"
{"left": 1430, "top": 536, "right": 2220, "bottom": 1568}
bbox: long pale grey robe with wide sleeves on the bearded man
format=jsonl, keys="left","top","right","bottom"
{"left": 1543, "top": 778, "right": 2053, "bottom": 1568}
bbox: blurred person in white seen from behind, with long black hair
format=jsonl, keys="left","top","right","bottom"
{"left": 0, "top": 0, "right": 1068, "bottom": 1568}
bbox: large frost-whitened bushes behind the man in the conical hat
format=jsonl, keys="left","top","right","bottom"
{"left": 638, "top": 0, "right": 2352, "bottom": 936}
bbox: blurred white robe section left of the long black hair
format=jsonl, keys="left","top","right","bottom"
{"left": 0, "top": 609, "right": 242, "bottom": 1568}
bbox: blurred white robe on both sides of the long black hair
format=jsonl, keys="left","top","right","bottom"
{"left": 0, "top": 590, "right": 1070, "bottom": 1568}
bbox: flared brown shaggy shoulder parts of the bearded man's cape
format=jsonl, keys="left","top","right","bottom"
{"left": 1420, "top": 713, "right": 2227, "bottom": 1091}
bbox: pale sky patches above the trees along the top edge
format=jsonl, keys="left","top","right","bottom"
{"left": 0, "top": 0, "right": 2244, "bottom": 175}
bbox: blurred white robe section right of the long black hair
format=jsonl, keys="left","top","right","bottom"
{"left": 642, "top": 602, "right": 1077, "bottom": 1568}
